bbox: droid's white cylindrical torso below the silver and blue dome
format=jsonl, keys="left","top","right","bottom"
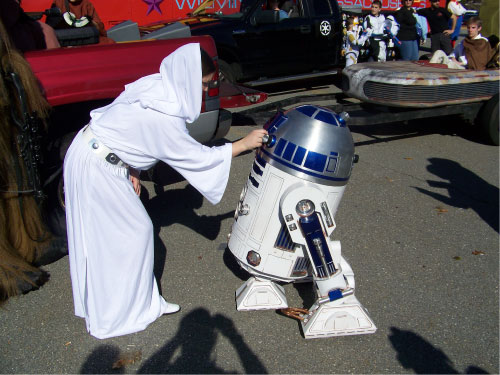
{"left": 228, "top": 162, "right": 345, "bottom": 282}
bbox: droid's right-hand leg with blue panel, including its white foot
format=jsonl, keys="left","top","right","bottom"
{"left": 299, "top": 201, "right": 377, "bottom": 339}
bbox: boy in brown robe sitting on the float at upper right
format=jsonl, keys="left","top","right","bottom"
{"left": 430, "top": 17, "right": 494, "bottom": 70}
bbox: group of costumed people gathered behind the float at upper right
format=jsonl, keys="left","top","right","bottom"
{"left": 344, "top": 0, "right": 498, "bottom": 70}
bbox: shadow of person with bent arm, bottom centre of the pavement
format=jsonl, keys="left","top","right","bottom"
{"left": 138, "top": 308, "right": 267, "bottom": 374}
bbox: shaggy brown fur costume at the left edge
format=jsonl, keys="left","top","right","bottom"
{"left": 0, "top": 22, "right": 50, "bottom": 304}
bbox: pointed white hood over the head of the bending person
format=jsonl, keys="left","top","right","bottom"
{"left": 124, "top": 43, "right": 202, "bottom": 122}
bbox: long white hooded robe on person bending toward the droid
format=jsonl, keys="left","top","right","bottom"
{"left": 64, "top": 43, "right": 232, "bottom": 339}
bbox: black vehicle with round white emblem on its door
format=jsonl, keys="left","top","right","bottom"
{"left": 184, "top": 0, "right": 342, "bottom": 85}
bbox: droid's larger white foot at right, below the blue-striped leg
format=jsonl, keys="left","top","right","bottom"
{"left": 301, "top": 295, "right": 377, "bottom": 339}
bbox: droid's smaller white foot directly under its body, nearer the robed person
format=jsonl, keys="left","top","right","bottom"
{"left": 236, "top": 277, "right": 288, "bottom": 311}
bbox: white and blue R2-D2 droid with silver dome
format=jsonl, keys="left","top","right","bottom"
{"left": 228, "top": 105, "right": 377, "bottom": 338}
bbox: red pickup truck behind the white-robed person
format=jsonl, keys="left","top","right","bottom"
{"left": 25, "top": 36, "right": 231, "bottom": 142}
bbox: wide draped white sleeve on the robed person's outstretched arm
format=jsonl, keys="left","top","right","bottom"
{"left": 143, "top": 118, "right": 232, "bottom": 204}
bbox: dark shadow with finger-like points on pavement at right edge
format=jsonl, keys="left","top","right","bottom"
{"left": 415, "top": 158, "right": 499, "bottom": 233}
